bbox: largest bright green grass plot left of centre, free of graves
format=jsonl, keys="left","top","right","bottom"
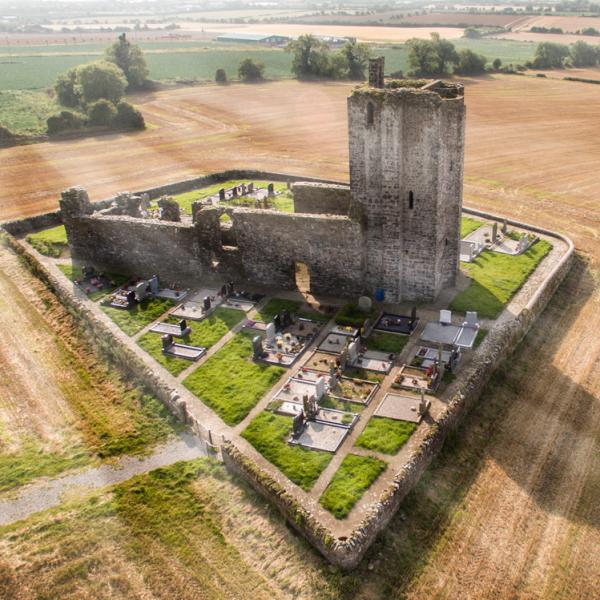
{"left": 183, "top": 333, "right": 285, "bottom": 425}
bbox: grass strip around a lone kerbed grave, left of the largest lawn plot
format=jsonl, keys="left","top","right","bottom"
{"left": 138, "top": 308, "right": 245, "bottom": 376}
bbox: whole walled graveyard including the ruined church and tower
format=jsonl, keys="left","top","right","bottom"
{"left": 2, "top": 61, "right": 570, "bottom": 568}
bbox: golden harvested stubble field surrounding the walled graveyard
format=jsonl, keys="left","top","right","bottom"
{"left": 0, "top": 72, "right": 600, "bottom": 600}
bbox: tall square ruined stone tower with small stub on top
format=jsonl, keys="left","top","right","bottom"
{"left": 348, "top": 60, "right": 465, "bottom": 301}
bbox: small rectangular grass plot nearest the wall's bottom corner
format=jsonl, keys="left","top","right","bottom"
{"left": 319, "top": 454, "right": 387, "bottom": 519}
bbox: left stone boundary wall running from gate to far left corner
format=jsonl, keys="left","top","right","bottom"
{"left": 0, "top": 231, "right": 219, "bottom": 455}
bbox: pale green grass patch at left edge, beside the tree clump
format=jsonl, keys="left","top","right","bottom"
{"left": 0, "top": 89, "right": 60, "bottom": 136}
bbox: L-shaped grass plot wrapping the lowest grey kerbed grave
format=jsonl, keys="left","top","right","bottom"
{"left": 242, "top": 412, "right": 333, "bottom": 491}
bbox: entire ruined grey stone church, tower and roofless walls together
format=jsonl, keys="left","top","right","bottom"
{"left": 60, "top": 59, "right": 465, "bottom": 302}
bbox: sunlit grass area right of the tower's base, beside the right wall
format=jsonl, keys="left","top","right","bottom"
{"left": 450, "top": 240, "right": 552, "bottom": 319}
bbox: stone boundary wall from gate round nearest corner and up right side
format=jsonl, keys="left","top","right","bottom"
{"left": 221, "top": 209, "right": 574, "bottom": 570}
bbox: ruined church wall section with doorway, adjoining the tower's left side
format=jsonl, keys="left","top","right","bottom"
{"left": 232, "top": 209, "right": 362, "bottom": 295}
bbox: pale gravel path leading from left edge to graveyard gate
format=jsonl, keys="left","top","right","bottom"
{"left": 0, "top": 434, "right": 207, "bottom": 525}
